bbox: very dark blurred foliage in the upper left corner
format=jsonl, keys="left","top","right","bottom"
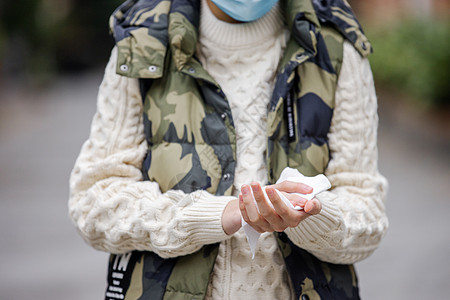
{"left": 0, "top": 0, "right": 123, "bottom": 81}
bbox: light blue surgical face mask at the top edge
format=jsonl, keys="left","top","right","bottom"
{"left": 211, "top": 0, "right": 278, "bottom": 22}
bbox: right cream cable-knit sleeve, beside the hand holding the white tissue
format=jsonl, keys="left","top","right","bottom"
{"left": 286, "top": 42, "right": 388, "bottom": 264}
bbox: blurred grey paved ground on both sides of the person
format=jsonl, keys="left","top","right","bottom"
{"left": 0, "top": 73, "right": 450, "bottom": 300}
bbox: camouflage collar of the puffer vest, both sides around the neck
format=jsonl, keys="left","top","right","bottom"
{"left": 110, "top": 0, "right": 372, "bottom": 78}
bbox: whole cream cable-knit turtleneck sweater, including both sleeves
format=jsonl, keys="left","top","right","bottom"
{"left": 69, "top": 2, "right": 388, "bottom": 299}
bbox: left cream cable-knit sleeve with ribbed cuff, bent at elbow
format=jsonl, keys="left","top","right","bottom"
{"left": 69, "top": 48, "right": 233, "bottom": 257}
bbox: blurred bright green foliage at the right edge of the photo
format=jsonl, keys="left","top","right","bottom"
{"left": 368, "top": 19, "right": 450, "bottom": 107}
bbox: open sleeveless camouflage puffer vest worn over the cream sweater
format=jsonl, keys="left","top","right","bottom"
{"left": 106, "top": 0, "right": 371, "bottom": 300}
